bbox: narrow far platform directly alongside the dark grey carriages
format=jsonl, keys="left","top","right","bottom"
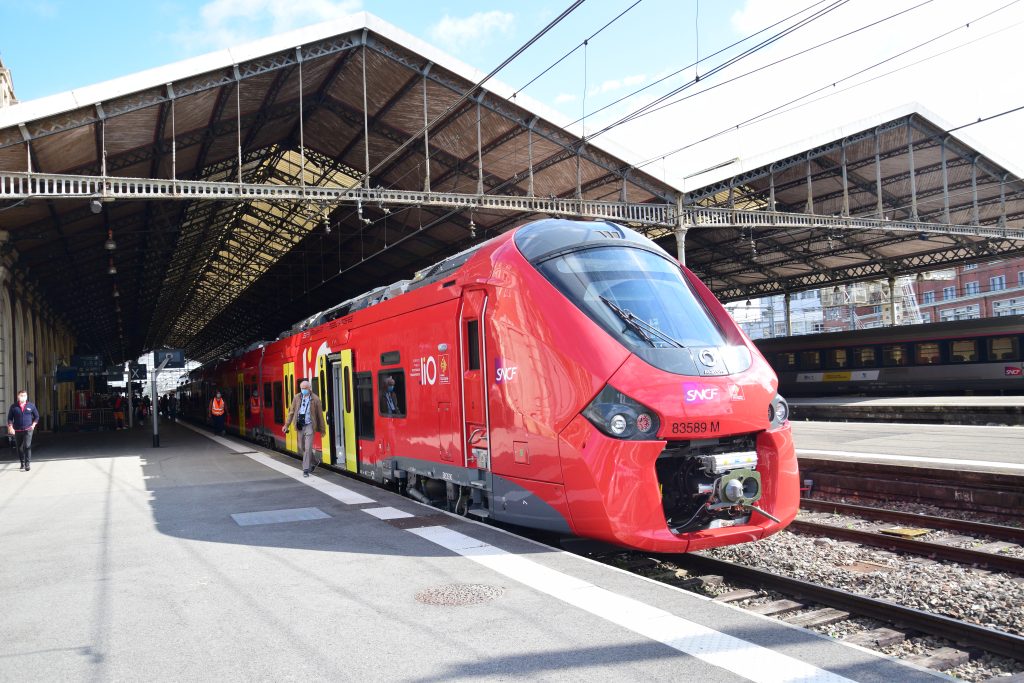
{"left": 787, "top": 395, "right": 1024, "bottom": 425}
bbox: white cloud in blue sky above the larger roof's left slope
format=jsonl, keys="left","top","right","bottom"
{"left": 175, "top": 0, "right": 362, "bottom": 52}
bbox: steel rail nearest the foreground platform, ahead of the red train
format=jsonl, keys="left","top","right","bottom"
{"left": 667, "top": 554, "right": 1024, "bottom": 658}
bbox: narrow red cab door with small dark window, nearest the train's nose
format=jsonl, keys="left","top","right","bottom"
{"left": 459, "top": 290, "right": 490, "bottom": 470}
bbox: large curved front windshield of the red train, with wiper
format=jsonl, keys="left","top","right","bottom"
{"left": 538, "top": 247, "right": 727, "bottom": 355}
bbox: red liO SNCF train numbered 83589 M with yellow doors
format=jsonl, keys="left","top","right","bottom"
{"left": 181, "top": 219, "right": 799, "bottom": 552}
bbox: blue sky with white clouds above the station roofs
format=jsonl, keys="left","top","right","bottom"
{"left": 0, "top": 0, "right": 1024, "bottom": 190}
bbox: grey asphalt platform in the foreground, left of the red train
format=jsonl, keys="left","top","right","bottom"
{"left": 0, "top": 424, "right": 936, "bottom": 683}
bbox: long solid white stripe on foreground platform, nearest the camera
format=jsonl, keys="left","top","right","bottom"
{"left": 409, "top": 526, "right": 852, "bottom": 683}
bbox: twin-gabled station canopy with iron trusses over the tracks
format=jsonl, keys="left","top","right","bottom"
{"left": 0, "top": 14, "right": 1024, "bottom": 362}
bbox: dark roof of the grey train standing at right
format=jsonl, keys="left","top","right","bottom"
{"left": 755, "top": 315, "right": 1024, "bottom": 352}
